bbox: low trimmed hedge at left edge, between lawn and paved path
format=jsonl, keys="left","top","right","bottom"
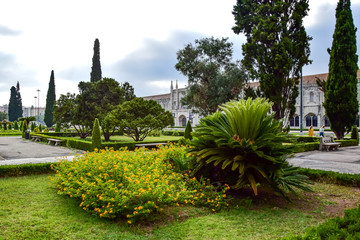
{"left": 0, "top": 163, "right": 54, "bottom": 178}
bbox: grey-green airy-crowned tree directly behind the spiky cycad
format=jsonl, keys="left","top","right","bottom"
{"left": 175, "top": 37, "right": 248, "bottom": 116}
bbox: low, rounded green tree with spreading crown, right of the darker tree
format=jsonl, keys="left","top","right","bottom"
{"left": 110, "top": 98, "right": 174, "bottom": 141}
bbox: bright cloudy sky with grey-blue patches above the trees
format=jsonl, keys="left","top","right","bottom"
{"left": 0, "top": 0, "right": 360, "bottom": 107}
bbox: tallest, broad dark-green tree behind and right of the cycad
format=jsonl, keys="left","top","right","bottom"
{"left": 232, "top": 0, "right": 312, "bottom": 124}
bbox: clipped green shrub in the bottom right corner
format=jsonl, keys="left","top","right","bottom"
{"left": 285, "top": 205, "right": 360, "bottom": 240}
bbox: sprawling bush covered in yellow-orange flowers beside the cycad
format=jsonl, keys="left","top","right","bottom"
{"left": 52, "top": 145, "right": 228, "bottom": 224}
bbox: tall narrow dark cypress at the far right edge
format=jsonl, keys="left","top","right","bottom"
{"left": 324, "top": 0, "right": 359, "bottom": 139}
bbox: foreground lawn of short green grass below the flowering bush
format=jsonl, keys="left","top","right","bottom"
{"left": 0, "top": 175, "right": 360, "bottom": 239}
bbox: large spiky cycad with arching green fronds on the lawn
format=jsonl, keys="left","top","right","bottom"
{"left": 189, "top": 98, "right": 310, "bottom": 199}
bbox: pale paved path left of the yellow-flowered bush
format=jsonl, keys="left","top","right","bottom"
{"left": 0, "top": 136, "right": 83, "bottom": 165}
